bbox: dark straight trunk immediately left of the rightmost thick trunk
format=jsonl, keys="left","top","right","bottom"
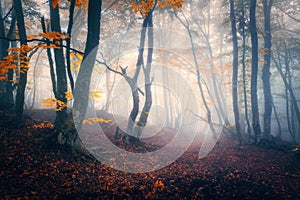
{"left": 249, "top": 0, "right": 261, "bottom": 143}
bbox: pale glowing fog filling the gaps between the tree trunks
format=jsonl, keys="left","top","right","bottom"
{"left": 25, "top": 1, "right": 300, "bottom": 145}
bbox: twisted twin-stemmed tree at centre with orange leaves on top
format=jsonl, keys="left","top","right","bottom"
{"left": 121, "top": 0, "right": 184, "bottom": 143}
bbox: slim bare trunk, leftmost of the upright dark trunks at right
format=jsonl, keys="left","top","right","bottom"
{"left": 230, "top": 0, "right": 242, "bottom": 144}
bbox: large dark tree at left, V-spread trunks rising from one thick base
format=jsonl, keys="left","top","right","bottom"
{"left": 42, "top": 0, "right": 102, "bottom": 156}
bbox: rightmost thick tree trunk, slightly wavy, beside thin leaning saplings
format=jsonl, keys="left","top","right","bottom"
{"left": 262, "top": 0, "right": 273, "bottom": 140}
